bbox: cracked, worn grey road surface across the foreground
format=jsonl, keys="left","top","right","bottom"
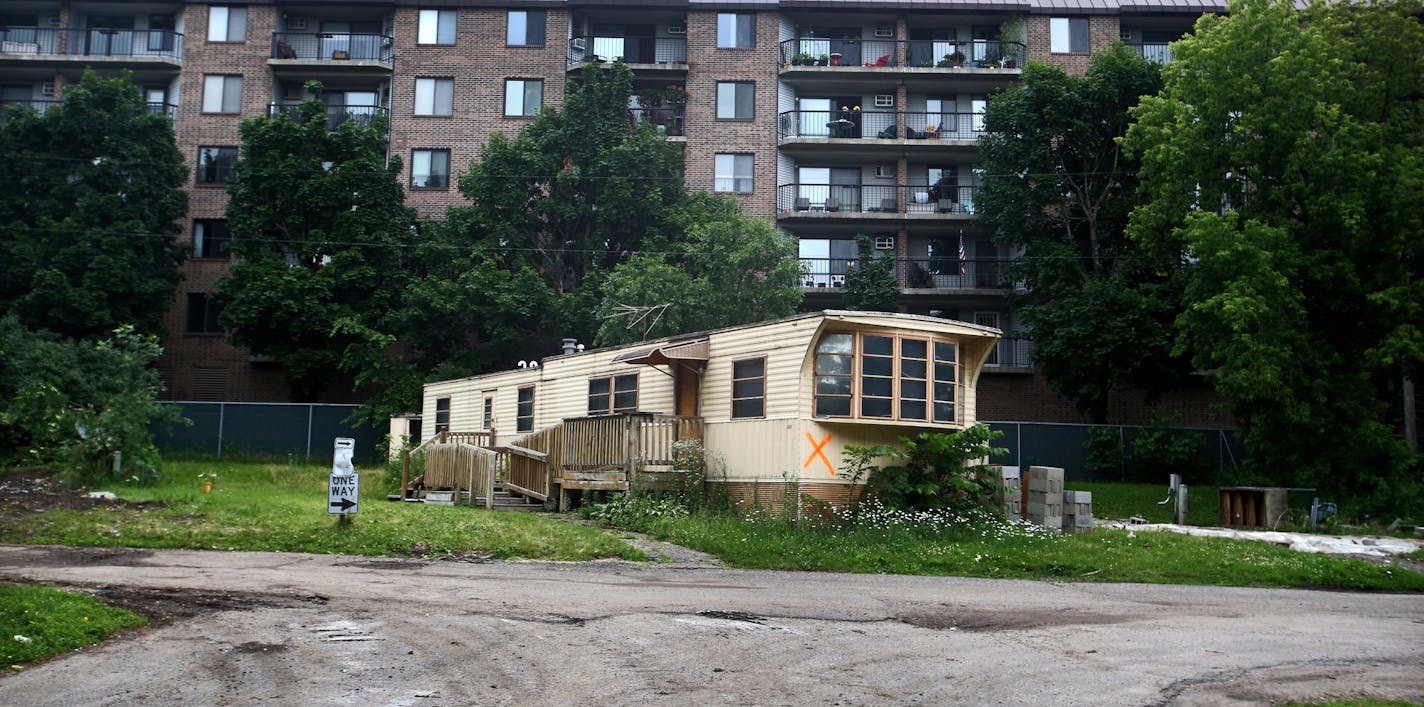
{"left": 0, "top": 546, "right": 1424, "bottom": 706}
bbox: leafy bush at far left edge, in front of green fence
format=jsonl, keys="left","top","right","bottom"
{"left": 0, "top": 316, "right": 185, "bottom": 483}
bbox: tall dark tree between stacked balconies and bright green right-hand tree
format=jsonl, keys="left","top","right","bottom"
{"left": 975, "top": 46, "right": 1185, "bottom": 422}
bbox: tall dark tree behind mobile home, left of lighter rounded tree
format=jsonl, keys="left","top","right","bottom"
{"left": 451, "top": 61, "right": 686, "bottom": 344}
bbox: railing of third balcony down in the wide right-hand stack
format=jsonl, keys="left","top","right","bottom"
{"left": 776, "top": 184, "right": 975, "bottom": 218}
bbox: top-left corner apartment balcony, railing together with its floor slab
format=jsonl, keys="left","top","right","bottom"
{"left": 0, "top": 27, "right": 182, "bottom": 68}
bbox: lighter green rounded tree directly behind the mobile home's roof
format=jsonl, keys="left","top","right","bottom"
{"left": 597, "top": 192, "right": 802, "bottom": 346}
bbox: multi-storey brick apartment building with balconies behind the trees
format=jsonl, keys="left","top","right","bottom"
{"left": 0, "top": 0, "right": 1225, "bottom": 422}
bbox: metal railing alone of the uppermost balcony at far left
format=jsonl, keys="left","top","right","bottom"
{"left": 0, "top": 27, "right": 182, "bottom": 58}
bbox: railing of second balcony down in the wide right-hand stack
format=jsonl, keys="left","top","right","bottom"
{"left": 776, "top": 110, "right": 984, "bottom": 140}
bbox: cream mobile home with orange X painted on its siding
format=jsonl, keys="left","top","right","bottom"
{"left": 407, "top": 311, "right": 1000, "bottom": 503}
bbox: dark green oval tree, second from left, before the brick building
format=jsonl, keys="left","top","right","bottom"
{"left": 218, "top": 84, "right": 416, "bottom": 401}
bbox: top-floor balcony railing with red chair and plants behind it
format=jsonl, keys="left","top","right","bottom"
{"left": 778, "top": 37, "right": 1028, "bottom": 70}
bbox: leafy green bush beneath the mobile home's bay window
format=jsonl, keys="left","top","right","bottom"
{"left": 866, "top": 425, "right": 1007, "bottom": 510}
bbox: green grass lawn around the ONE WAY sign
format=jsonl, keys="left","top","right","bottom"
{"left": 0, "top": 460, "right": 646, "bottom": 560}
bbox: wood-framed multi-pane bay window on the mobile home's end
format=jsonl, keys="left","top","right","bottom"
{"left": 815, "top": 334, "right": 958, "bottom": 422}
